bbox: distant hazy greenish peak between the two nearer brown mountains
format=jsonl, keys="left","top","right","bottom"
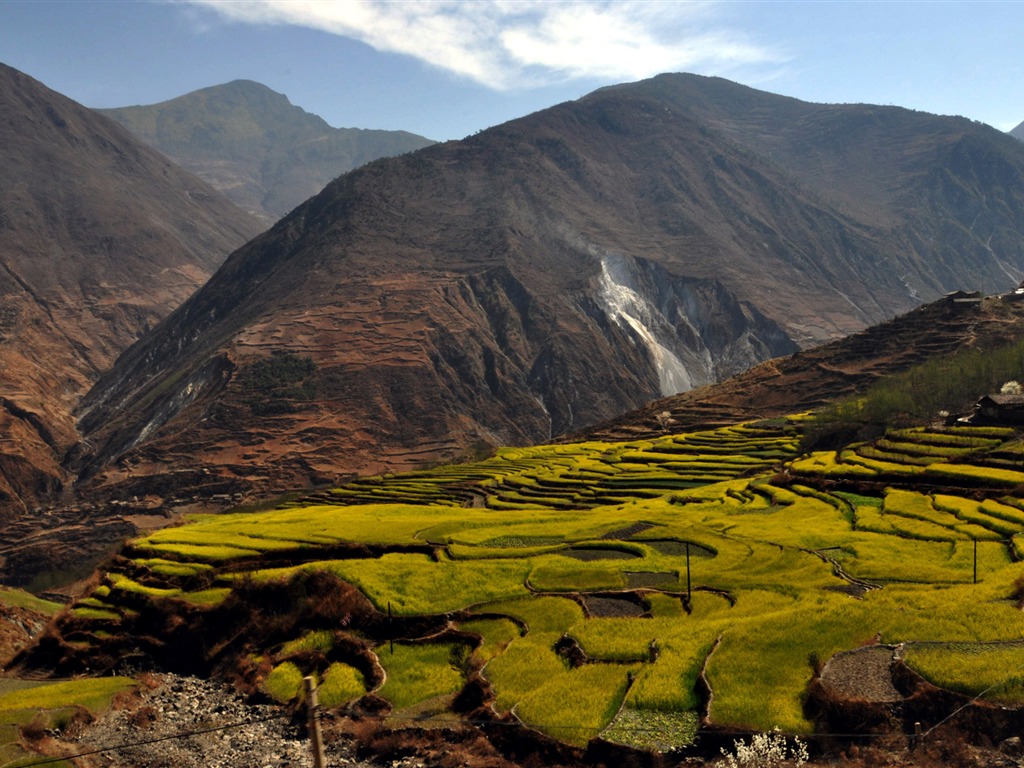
{"left": 98, "top": 80, "right": 433, "bottom": 224}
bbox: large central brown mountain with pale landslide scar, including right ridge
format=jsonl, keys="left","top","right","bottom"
{"left": 76, "top": 75, "right": 1024, "bottom": 505}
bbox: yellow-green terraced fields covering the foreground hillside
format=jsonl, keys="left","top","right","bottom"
{"left": 37, "top": 417, "right": 1024, "bottom": 750}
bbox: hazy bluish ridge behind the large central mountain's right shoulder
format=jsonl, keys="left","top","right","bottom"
{"left": 611, "top": 76, "right": 1024, "bottom": 305}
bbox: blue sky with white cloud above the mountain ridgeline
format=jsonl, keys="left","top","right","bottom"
{"left": 0, "top": 0, "right": 1024, "bottom": 140}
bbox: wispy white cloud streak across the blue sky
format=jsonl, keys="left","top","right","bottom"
{"left": 186, "top": 0, "right": 782, "bottom": 90}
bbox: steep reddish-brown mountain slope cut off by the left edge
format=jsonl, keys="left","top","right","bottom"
{"left": 0, "top": 65, "right": 262, "bottom": 518}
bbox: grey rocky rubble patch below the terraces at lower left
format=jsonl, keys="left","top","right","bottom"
{"left": 65, "top": 675, "right": 407, "bottom": 768}
